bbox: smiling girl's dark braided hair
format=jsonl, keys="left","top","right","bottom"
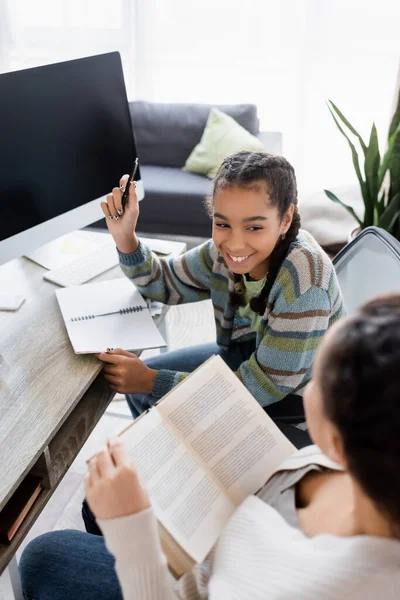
{"left": 207, "top": 151, "right": 300, "bottom": 315}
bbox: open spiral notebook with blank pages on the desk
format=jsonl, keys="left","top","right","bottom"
{"left": 56, "top": 277, "right": 166, "bottom": 354}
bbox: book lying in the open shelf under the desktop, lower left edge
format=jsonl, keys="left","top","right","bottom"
{"left": 0, "top": 474, "right": 42, "bottom": 544}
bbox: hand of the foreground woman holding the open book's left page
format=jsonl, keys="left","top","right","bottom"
{"left": 85, "top": 438, "right": 150, "bottom": 519}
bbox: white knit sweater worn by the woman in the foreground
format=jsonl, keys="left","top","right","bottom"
{"left": 100, "top": 447, "right": 400, "bottom": 600}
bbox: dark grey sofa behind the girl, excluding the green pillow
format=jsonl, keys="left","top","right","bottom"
{"left": 94, "top": 101, "right": 282, "bottom": 237}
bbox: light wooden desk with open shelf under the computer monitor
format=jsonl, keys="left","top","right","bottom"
{"left": 0, "top": 237, "right": 186, "bottom": 584}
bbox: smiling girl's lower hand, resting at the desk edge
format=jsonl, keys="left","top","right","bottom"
{"left": 97, "top": 348, "right": 157, "bottom": 394}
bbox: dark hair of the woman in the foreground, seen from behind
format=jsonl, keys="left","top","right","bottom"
{"left": 321, "top": 294, "right": 400, "bottom": 535}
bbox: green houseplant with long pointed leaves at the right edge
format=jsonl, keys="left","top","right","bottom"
{"left": 324, "top": 91, "right": 400, "bottom": 240}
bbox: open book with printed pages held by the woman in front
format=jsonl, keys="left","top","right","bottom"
{"left": 121, "top": 356, "right": 295, "bottom": 575}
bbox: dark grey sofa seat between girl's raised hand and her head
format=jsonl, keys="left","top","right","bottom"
{"left": 137, "top": 165, "right": 211, "bottom": 237}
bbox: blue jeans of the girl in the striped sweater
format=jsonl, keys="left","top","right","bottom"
{"left": 126, "top": 340, "right": 256, "bottom": 419}
